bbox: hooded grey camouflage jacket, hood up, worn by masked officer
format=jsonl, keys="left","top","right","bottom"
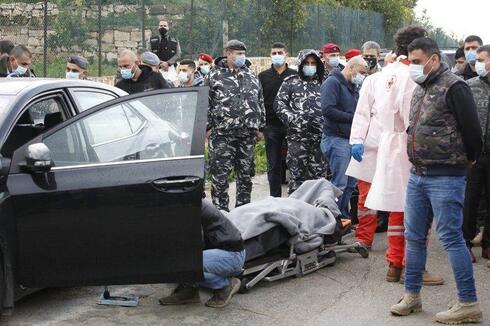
{"left": 274, "top": 50, "right": 324, "bottom": 140}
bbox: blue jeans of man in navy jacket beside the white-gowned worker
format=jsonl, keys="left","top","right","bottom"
{"left": 320, "top": 135, "right": 357, "bottom": 218}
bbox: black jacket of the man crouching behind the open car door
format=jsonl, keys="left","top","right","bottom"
{"left": 201, "top": 199, "right": 244, "bottom": 251}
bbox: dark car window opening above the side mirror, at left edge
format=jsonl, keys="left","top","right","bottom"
{"left": 1, "top": 96, "right": 66, "bottom": 157}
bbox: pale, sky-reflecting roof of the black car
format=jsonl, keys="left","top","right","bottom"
{"left": 0, "top": 78, "right": 127, "bottom": 96}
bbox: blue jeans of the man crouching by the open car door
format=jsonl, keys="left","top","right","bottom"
{"left": 199, "top": 249, "right": 245, "bottom": 290}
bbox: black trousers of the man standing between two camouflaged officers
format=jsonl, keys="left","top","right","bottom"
{"left": 264, "top": 125, "right": 286, "bottom": 197}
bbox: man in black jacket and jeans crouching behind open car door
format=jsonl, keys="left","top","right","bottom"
{"left": 159, "top": 200, "right": 245, "bottom": 308}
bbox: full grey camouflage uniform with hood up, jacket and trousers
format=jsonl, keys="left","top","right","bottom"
{"left": 274, "top": 50, "right": 326, "bottom": 194}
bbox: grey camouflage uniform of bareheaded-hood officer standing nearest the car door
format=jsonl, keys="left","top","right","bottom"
{"left": 205, "top": 57, "right": 265, "bottom": 210}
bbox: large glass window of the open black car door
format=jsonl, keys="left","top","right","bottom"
{"left": 43, "top": 92, "right": 197, "bottom": 166}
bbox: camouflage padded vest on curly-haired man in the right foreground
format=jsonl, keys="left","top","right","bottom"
{"left": 407, "top": 66, "right": 468, "bottom": 174}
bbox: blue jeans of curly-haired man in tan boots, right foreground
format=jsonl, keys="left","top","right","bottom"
{"left": 404, "top": 174, "right": 477, "bottom": 303}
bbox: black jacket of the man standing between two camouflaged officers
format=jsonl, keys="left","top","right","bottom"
{"left": 259, "top": 66, "right": 297, "bottom": 126}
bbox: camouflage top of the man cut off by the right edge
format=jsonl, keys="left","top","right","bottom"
{"left": 468, "top": 77, "right": 490, "bottom": 153}
